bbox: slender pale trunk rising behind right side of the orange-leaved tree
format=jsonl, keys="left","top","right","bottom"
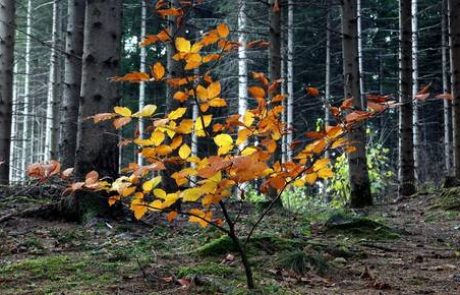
{"left": 286, "top": 0, "right": 294, "bottom": 161}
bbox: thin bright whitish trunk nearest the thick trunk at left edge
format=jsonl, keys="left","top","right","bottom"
{"left": 21, "top": 0, "right": 34, "bottom": 178}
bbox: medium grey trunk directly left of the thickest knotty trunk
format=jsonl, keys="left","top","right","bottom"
{"left": 59, "top": 0, "right": 86, "bottom": 168}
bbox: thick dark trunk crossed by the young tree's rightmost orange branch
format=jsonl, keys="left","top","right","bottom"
{"left": 342, "top": 0, "right": 372, "bottom": 208}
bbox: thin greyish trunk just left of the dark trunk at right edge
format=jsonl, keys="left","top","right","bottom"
{"left": 441, "top": 0, "right": 452, "bottom": 176}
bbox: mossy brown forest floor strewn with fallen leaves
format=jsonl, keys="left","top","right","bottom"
{"left": 0, "top": 190, "right": 460, "bottom": 295}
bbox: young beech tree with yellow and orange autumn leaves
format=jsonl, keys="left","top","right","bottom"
{"left": 29, "top": 2, "right": 390, "bottom": 289}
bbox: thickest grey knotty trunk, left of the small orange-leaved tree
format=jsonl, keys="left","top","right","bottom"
{"left": 75, "top": 0, "right": 121, "bottom": 177}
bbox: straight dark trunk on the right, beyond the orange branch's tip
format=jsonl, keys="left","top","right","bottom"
{"left": 399, "top": 0, "right": 416, "bottom": 196}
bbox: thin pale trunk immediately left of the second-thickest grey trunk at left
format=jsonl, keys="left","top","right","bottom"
{"left": 44, "top": 0, "right": 62, "bottom": 162}
